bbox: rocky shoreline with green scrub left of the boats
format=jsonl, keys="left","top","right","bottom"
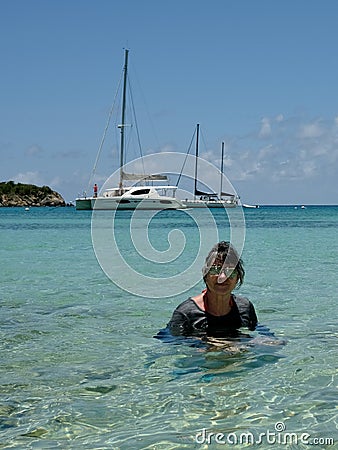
{"left": 0, "top": 181, "right": 72, "bottom": 207}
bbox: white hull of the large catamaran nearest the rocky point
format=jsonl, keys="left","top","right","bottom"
{"left": 75, "top": 197, "right": 186, "bottom": 211}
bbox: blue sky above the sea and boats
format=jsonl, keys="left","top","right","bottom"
{"left": 0, "top": 0, "right": 338, "bottom": 204}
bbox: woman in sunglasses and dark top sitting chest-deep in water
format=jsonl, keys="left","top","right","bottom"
{"left": 167, "top": 241, "right": 257, "bottom": 337}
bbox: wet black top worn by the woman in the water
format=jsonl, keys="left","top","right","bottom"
{"left": 167, "top": 295, "right": 257, "bottom": 336}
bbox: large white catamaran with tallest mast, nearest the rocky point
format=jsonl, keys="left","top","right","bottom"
{"left": 76, "top": 49, "right": 186, "bottom": 210}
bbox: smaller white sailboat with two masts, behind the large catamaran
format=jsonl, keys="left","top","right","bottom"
{"left": 182, "top": 124, "right": 239, "bottom": 208}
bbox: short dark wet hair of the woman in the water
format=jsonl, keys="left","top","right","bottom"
{"left": 202, "top": 241, "right": 245, "bottom": 287}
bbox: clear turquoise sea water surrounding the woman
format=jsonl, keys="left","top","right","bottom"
{"left": 0, "top": 206, "right": 338, "bottom": 450}
